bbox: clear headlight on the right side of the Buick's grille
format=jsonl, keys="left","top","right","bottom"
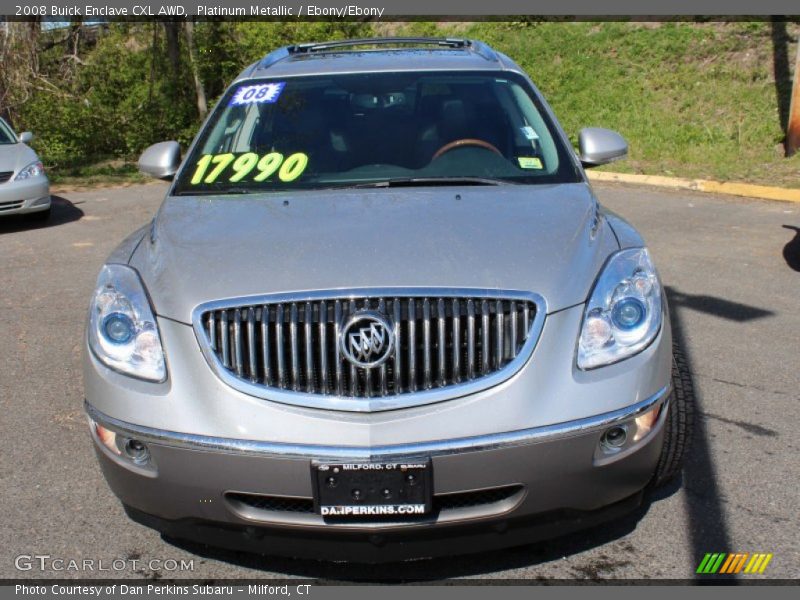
{"left": 578, "top": 248, "right": 661, "bottom": 369}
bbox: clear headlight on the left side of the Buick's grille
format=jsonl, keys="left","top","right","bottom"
{"left": 89, "top": 264, "right": 167, "bottom": 381}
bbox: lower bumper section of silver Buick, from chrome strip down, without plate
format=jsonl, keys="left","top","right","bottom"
{"left": 86, "top": 388, "right": 669, "bottom": 562}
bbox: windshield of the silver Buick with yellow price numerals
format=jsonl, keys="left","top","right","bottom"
{"left": 175, "top": 72, "right": 579, "bottom": 194}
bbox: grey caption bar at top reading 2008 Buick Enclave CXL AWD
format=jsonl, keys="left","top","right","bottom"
{"left": 0, "top": 0, "right": 800, "bottom": 20}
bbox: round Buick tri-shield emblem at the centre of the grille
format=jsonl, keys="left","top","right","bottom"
{"left": 339, "top": 310, "right": 394, "bottom": 369}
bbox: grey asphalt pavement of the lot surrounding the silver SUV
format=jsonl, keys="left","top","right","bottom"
{"left": 0, "top": 184, "right": 800, "bottom": 580}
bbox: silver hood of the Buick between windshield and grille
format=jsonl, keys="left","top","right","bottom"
{"left": 131, "top": 183, "right": 618, "bottom": 323}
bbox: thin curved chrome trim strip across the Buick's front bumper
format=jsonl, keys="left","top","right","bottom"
{"left": 84, "top": 385, "right": 670, "bottom": 461}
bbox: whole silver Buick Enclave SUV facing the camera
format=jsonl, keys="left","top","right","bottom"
{"left": 84, "top": 38, "right": 691, "bottom": 561}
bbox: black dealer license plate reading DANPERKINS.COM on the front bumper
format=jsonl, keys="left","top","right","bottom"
{"left": 311, "top": 459, "right": 433, "bottom": 519}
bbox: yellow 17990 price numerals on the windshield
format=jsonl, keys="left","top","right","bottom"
{"left": 191, "top": 152, "right": 308, "bottom": 185}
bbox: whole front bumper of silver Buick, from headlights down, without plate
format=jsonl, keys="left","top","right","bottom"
{"left": 84, "top": 305, "right": 672, "bottom": 561}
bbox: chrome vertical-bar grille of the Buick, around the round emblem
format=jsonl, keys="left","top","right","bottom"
{"left": 195, "top": 290, "right": 544, "bottom": 411}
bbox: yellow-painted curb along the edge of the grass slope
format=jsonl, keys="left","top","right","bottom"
{"left": 587, "top": 171, "right": 800, "bottom": 202}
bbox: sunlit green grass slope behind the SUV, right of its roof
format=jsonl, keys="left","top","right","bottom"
{"left": 388, "top": 22, "right": 800, "bottom": 187}
